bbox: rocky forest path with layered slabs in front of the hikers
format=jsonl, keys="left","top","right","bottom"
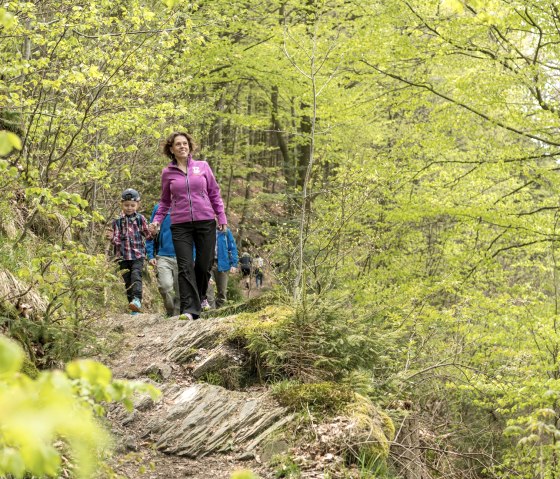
{"left": 98, "top": 314, "right": 290, "bottom": 479}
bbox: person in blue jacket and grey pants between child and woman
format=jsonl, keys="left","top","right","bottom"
{"left": 146, "top": 203, "right": 180, "bottom": 316}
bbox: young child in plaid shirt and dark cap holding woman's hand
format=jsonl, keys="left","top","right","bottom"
{"left": 111, "top": 188, "right": 151, "bottom": 314}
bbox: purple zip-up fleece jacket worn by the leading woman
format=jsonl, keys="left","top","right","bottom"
{"left": 153, "top": 156, "right": 227, "bottom": 224}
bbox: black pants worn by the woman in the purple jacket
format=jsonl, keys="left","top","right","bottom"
{"left": 171, "top": 220, "right": 216, "bottom": 318}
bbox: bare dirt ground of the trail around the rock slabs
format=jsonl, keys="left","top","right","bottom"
{"left": 99, "top": 314, "right": 280, "bottom": 479}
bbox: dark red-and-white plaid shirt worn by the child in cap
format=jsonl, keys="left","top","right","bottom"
{"left": 111, "top": 213, "right": 151, "bottom": 260}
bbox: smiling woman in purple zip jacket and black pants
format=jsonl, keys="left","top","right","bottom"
{"left": 150, "top": 132, "right": 227, "bottom": 319}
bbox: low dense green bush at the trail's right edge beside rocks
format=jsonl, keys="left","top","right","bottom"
{"left": 231, "top": 302, "right": 380, "bottom": 382}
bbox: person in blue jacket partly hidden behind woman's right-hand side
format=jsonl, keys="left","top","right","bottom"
{"left": 209, "top": 228, "right": 239, "bottom": 308}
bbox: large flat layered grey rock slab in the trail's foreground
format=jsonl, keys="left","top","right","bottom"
{"left": 144, "top": 384, "right": 292, "bottom": 458}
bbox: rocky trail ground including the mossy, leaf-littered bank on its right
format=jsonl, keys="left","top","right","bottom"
{"left": 102, "top": 314, "right": 398, "bottom": 479}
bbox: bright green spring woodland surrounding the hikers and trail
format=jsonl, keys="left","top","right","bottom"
{"left": 0, "top": 0, "right": 560, "bottom": 479}
